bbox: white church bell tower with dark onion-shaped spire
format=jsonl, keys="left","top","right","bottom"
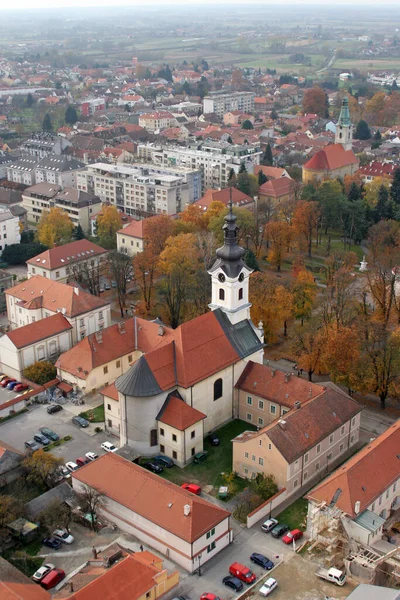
{"left": 208, "top": 189, "right": 252, "bottom": 324}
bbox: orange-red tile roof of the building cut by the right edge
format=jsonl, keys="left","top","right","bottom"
{"left": 306, "top": 420, "right": 400, "bottom": 518}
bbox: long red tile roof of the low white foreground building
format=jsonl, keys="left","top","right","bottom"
{"left": 72, "top": 452, "right": 230, "bottom": 543}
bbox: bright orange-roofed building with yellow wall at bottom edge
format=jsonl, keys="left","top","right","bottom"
{"left": 53, "top": 543, "right": 179, "bottom": 600}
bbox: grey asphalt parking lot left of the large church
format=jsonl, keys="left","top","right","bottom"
{"left": 0, "top": 404, "right": 113, "bottom": 462}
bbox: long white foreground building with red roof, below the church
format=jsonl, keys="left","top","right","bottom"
{"left": 72, "top": 452, "right": 233, "bottom": 573}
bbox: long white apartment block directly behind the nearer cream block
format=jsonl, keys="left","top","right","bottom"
{"left": 137, "top": 141, "right": 262, "bottom": 191}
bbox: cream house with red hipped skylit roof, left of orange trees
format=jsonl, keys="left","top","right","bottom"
{"left": 26, "top": 239, "right": 107, "bottom": 283}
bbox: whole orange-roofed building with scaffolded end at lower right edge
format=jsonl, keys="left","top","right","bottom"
{"left": 307, "top": 420, "right": 400, "bottom": 547}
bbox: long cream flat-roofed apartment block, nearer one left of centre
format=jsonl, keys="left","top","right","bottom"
{"left": 77, "top": 163, "right": 197, "bottom": 218}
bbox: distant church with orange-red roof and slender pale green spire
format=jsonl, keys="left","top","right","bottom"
{"left": 303, "top": 96, "right": 359, "bottom": 183}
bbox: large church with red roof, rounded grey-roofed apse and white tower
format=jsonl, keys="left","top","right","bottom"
{"left": 113, "top": 199, "right": 267, "bottom": 466}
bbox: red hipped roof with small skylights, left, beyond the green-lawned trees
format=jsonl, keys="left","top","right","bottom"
{"left": 26, "top": 240, "right": 107, "bottom": 269}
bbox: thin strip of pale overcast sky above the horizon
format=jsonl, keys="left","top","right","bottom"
{"left": 0, "top": 0, "right": 399, "bottom": 10}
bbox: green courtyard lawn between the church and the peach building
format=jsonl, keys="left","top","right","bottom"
{"left": 156, "top": 419, "right": 256, "bottom": 495}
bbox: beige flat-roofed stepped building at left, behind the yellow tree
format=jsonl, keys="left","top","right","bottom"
{"left": 22, "top": 183, "right": 101, "bottom": 232}
